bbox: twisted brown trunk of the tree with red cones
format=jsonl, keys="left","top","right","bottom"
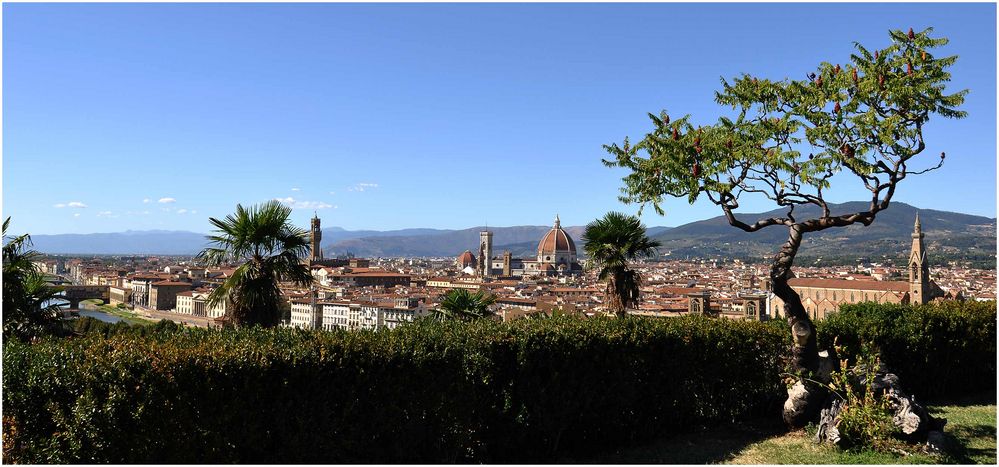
{"left": 770, "top": 224, "right": 828, "bottom": 428}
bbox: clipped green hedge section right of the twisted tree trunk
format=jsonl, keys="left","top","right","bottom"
{"left": 816, "top": 301, "right": 996, "bottom": 398}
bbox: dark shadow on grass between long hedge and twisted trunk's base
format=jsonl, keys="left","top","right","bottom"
{"left": 559, "top": 420, "right": 787, "bottom": 464}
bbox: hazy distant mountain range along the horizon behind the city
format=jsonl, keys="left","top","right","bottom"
{"left": 21, "top": 202, "right": 996, "bottom": 268}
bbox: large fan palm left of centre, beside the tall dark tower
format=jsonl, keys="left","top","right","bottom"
{"left": 198, "top": 201, "right": 312, "bottom": 327}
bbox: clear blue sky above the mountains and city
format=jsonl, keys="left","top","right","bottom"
{"left": 3, "top": 4, "right": 996, "bottom": 234}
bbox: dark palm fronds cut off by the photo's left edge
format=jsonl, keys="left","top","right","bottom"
{"left": 3, "top": 217, "right": 62, "bottom": 338}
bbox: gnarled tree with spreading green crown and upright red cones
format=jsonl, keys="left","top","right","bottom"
{"left": 604, "top": 29, "right": 968, "bottom": 425}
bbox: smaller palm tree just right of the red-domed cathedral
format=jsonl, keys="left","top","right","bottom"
{"left": 583, "top": 212, "right": 660, "bottom": 316}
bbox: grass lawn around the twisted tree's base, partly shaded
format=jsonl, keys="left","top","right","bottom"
{"left": 590, "top": 395, "right": 996, "bottom": 464}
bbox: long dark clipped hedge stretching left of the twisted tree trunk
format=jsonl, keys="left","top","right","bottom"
{"left": 3, "top": 316, "right": 786, "bottom": 463}
